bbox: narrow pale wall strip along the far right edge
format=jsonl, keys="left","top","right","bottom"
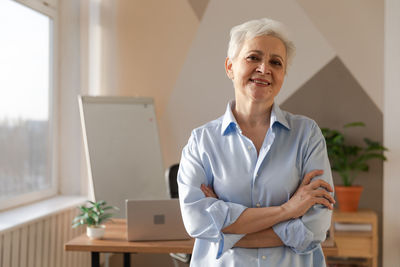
{"left": 383, "top": 0, "right": 400, "bottom": 267}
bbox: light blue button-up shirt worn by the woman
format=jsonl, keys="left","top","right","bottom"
{"left": 178, "top": 102, "right": 333, "bottom": 267}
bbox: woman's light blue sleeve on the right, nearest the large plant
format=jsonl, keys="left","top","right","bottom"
{"left": 273, "top": 123, "right": 333, "bottom": 254}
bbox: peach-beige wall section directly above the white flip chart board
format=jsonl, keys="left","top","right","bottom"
{"left": 112, "top": 0, "right": 199, "bottom": 167}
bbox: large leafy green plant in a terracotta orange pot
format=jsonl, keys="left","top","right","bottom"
{"left": 321, "top": 122, "right": 387, "bottom": 211}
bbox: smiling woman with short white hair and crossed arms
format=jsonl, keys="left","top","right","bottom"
{"left": 178, "top": 19, "right": 335, "bottom": 267}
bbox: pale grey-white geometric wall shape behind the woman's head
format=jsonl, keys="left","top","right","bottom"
{"left": 160, "top": 0, "right": 335, "bottom": 160}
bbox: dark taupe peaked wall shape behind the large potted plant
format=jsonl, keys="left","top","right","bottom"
{"left": 280, "top": 57, "right": 383, "bottom": 264}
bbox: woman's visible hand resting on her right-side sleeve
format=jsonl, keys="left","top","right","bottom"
{"left": 282, "top": 170, "right": 335, "bottom": 218}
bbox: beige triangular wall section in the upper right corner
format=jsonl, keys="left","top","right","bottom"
{"left": 297, "top": 0, "right": 384, "bottom": 110}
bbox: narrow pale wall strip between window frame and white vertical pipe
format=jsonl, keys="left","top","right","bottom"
{"left": 58, "top": 0, "right": 81, "bottom": 195}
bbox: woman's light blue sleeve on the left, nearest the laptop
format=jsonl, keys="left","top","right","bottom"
{"left": 178, "top": 132, "right": 247, "bottom": 258}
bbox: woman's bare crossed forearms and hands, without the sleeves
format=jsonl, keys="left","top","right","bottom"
{"left": 201, "top": 170, "right": 335, "bottom": 248}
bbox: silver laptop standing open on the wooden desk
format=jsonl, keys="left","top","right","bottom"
{"left": 126, "top": 199, "right": 190, "bottom": 241}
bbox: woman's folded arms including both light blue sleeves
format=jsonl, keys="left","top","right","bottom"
{"left": 178, "top": 126, "right": 334, "bottom": 254}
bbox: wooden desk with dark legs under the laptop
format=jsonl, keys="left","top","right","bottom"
{"left": 64, "top": 219, "right": 338, "bottom": 267}
